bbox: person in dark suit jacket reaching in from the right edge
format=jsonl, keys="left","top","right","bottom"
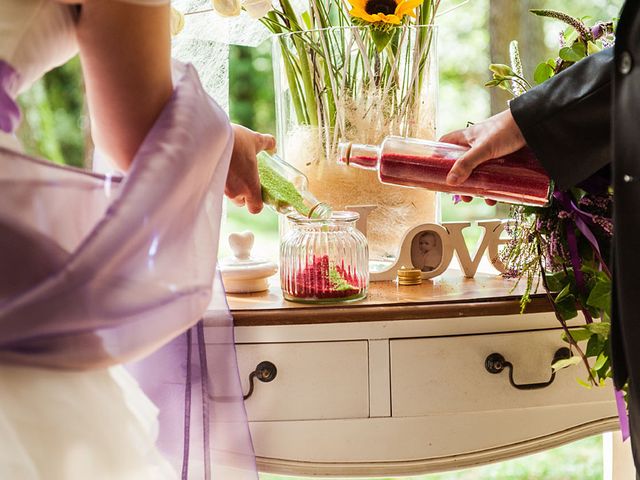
{"left": 441, "top": 0, "right": 640, "bottom": 480}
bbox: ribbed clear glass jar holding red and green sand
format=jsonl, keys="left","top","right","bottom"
{"left": 280, "top": 212, "right": 369, "bottom": 303}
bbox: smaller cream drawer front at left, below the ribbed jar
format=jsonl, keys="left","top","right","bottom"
{"left": 237, "top": 341, "right": 369, "bottom": 421}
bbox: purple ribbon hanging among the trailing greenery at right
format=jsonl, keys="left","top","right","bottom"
{"left": 553, "top": 190, "right": 630, "bottom": 440}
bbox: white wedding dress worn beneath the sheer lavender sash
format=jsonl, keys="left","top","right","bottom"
{"left": 0, "top": 0, "right": 178, "bottom": 480}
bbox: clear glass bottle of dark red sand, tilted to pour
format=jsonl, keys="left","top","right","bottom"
{"left": 338, "top": 136, "right": 553, "bottom": 207}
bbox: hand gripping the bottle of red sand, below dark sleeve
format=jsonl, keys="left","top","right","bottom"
{"left": 440, "top": 109, "right": 526, "bottom": 185}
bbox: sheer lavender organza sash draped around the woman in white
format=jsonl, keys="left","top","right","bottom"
{"left": 0, "top": 65, "right": 257, "bottom": 480}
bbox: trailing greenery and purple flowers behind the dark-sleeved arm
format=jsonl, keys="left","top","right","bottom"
{"left": 487, "top": 10, "right": 614, "bottom": 394}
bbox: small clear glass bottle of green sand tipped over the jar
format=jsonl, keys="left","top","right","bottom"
{"left": 258, "top": 152, "right": 332, "bottom": 219}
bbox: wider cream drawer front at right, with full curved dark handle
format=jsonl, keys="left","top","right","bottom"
{"left": 390, "top": 330, "right": 613, "bottom": 417}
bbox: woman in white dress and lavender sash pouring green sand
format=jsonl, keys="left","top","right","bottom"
{"left": 0, "top": 0, "right": 274, "bottom": 480}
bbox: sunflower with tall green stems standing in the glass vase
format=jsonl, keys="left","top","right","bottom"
{"left": 255, "top": 0, "right": 440, "bottom": 158}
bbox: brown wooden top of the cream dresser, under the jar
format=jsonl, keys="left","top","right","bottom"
{"left": 227, "top": 270, "right": 551, "bottom": 326}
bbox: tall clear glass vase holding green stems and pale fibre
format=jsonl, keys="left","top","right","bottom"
{"left": 273, "top": 25, "right": 438, "bottom": 271}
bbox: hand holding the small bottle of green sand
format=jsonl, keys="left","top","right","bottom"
{"left": 224, "top": 125, "right": 276, "bottom": 213}
